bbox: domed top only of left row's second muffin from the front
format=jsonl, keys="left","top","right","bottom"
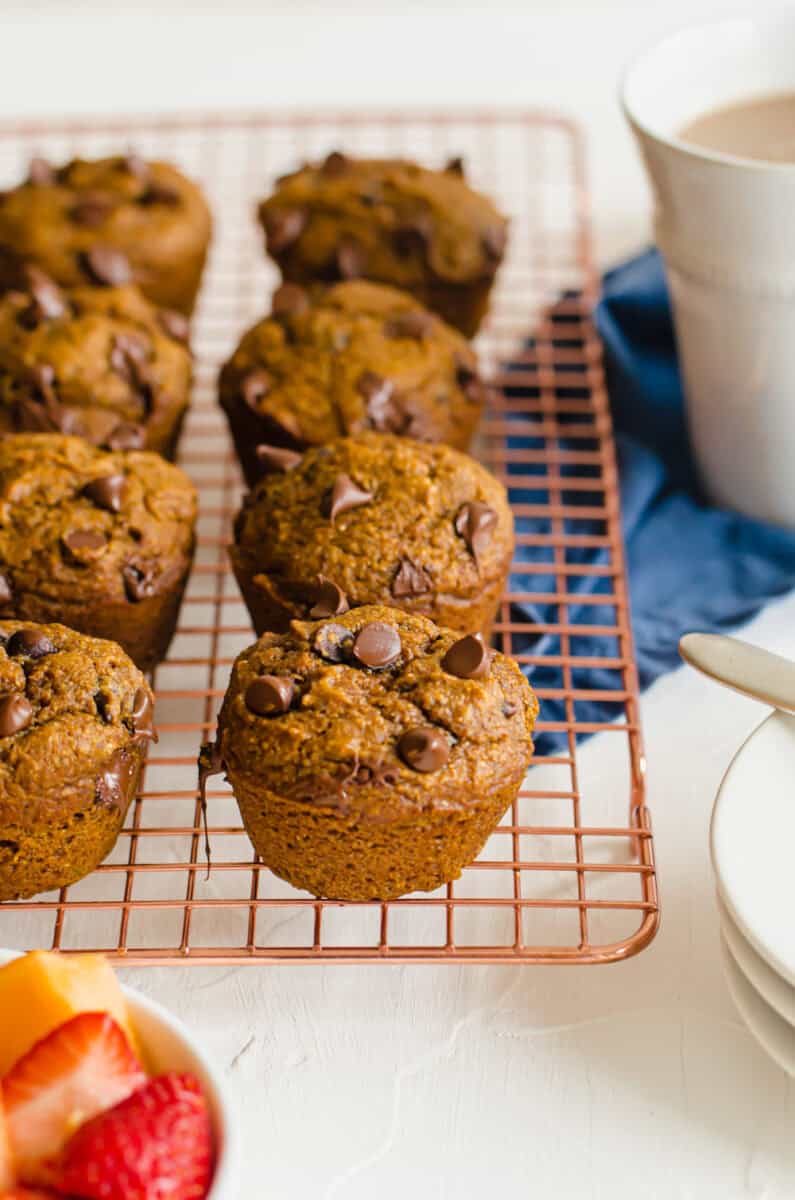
{"left": 0, "top": 433, "right": 196, "bottom": 607}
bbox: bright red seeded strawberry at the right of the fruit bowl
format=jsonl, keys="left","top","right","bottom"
{"left": 55, "top": 1072, "right": 213, "bottom": 1200}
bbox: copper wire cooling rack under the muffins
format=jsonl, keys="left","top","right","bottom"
{"left": 0, "top": 113, "right": 658, "bottom": 965}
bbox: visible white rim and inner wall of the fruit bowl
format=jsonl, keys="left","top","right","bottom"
{"left": 0, "top": 950, "right": 241, "bottom": 1200}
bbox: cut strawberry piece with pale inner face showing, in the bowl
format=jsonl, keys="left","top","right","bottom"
{"left": 2, "top": 1013, "right": 147, "bottom": 1183}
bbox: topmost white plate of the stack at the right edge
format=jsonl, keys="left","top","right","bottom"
{"left": 710, "top": 712, "right": 795, "bottom": 986}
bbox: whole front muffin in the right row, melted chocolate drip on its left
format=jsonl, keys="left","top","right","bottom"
{"left": 202, "top": 605, "right": 538, "bottom": 900}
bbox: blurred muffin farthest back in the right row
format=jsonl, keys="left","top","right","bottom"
{"left": 259, "top": 151, "right": 508, "bottom": 337}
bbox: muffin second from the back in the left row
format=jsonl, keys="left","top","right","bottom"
{"left": 0, "top": 274, "right": 191, "bottom": 458}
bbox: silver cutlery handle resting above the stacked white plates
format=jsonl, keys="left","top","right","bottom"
{"left": 679, "top": 634, "right": 795, "bottom": 713}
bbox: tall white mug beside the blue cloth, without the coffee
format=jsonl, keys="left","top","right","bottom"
{"left": 621, "top": 8, "right": 795, "bottom": 529}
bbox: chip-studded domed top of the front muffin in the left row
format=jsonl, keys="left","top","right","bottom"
{"left": 0, "top": 620, "right": 154, "bottom": 827}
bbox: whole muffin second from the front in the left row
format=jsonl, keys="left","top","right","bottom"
{"left": 0, "top": 433, "right": 196, "bottom": 670}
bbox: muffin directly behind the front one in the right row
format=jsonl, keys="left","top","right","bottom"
{"left": 231, "top": 433, "right": 514, "bottom": 634}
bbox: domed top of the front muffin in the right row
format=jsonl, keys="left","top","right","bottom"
{"left": 216, "top": 605, "right": 538, "bottom": 823}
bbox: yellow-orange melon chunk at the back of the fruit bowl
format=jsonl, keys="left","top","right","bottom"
{"left": 0, "top": 950, "right": 136, "bottom": 1078}
